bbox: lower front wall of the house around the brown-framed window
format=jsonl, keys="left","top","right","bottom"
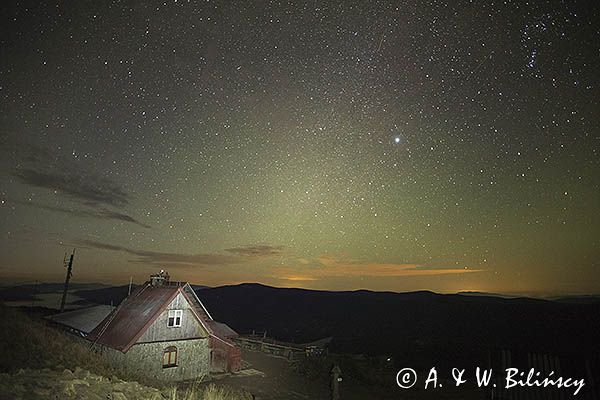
{"left": 102, "top": 339, "right": 210, "bottom": 381}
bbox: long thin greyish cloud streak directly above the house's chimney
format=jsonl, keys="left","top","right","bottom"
{"left": 75, "top": 239, "right": 286, "bottom": 267}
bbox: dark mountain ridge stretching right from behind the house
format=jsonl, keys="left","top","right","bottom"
{"left": 200, "top": 284, "right": 600, "bottom": 353}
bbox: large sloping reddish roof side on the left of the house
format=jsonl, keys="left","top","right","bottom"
{"left": 87, "top": 284, "right": 181, "bottom": 352}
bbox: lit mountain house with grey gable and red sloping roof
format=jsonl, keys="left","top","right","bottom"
{"left": 79, "top": 273, "right": 241, "bottom": 381}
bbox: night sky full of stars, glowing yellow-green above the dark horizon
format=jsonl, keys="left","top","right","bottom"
{"left": 0, "top": 0, "right": 600, "bottom": 294}
